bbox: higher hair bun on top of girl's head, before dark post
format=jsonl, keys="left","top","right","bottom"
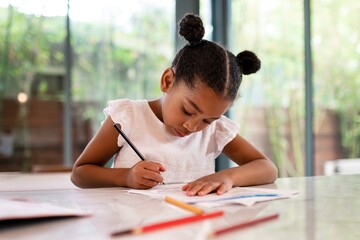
{"left": 179, "top": 14, "right": 205, "bottom": 46}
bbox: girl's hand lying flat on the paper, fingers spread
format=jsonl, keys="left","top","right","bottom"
{"left": 182, "top": 172, "right": 233, "bottom": 196}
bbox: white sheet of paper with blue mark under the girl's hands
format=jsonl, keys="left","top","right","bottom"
{"left": 128, "top": 184, "right": 299, "bottom": 207}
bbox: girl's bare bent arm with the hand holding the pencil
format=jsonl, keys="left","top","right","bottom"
{"left": 71, "top": 117, "right": 165, "bottom": 188}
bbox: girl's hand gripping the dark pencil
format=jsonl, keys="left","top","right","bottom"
{"left": 127, "top": 161, "right": 165, "bottom": 189}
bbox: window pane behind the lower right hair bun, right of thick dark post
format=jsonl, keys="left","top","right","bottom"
{"left": 230, "top": 0, "right": 304, "bottom": 176}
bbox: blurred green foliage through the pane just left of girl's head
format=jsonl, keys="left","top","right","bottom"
{"left": 72, "top": 8, "right": 172, "bottom": 109}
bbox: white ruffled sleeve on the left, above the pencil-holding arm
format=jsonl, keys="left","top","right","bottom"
{"left": 103, "top": 99, "right": 134, "bottom": 147}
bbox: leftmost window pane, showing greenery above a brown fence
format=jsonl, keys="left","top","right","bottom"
{"left": 0, "top": 0, "right": 66, "bottom": 171}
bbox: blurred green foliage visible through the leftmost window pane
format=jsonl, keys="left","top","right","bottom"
{"left": 0, "top": 7, "right": 64, "bottom": 98}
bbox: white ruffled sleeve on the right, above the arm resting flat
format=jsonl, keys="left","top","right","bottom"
{"left": 215, "top": 116, "right": 240, "bottom": 154}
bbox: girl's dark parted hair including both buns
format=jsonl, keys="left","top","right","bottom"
{"left": 171, "top": 14, "right": 261, "bottom": 101}
